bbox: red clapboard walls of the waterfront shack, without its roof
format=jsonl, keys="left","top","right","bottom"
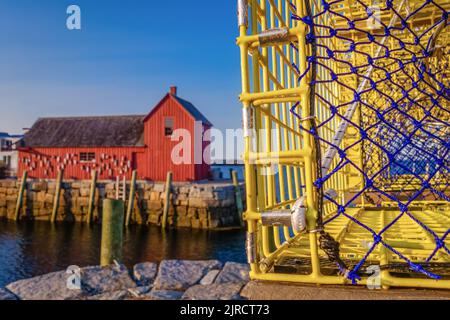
{"left": 19, "top": 94, "right": 211, "bottom": 181}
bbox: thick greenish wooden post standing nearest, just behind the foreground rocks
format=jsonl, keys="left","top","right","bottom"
{"left": 100, "top": 199, "right": 124, "bottom": 267}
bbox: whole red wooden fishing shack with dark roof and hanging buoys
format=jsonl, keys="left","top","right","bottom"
{"left": 19, "top": 87, "right": 212, "bottom": 181}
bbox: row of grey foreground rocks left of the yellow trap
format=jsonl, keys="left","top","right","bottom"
{"left": 0, "top": 260, "right": 249, "bottom": 300}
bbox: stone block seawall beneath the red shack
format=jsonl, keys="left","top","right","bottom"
{"left": 0, "top": 180, "right": 245, "bottom": 229}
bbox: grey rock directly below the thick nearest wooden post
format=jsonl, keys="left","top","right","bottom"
{"left": 81, "top": 265, "right": 137, "bottom": 295}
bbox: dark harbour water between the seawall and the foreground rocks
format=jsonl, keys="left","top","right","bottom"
{"left": 0, "top": 221, "right": 245, "bottom": 287}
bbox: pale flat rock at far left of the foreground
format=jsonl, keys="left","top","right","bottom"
{"left": 6, "top": 271, "right": 83, "bottom": 300}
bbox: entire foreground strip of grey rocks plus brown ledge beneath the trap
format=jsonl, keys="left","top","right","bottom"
{"left": 0, "top": 260, "right": 450, "bottom": 300}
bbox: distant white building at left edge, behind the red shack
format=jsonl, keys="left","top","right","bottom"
{"left": 0, "top": 132, "right": 23, "bottom": 177}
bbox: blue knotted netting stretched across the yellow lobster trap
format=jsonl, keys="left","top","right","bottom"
{"left": 291, "top": 0, "right": 450, "bottom": 283}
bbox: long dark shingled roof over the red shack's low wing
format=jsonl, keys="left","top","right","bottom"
{"left": 22, "top": 115, "right": 145, "bottom": 148}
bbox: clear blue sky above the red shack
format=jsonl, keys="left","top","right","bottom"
{"left": 0, "top": 0, "right": 241, "bottom": 133}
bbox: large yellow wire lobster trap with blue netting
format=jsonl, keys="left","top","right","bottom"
{"left": 237, "top": 0, "right": 450, "bottom": 289}
